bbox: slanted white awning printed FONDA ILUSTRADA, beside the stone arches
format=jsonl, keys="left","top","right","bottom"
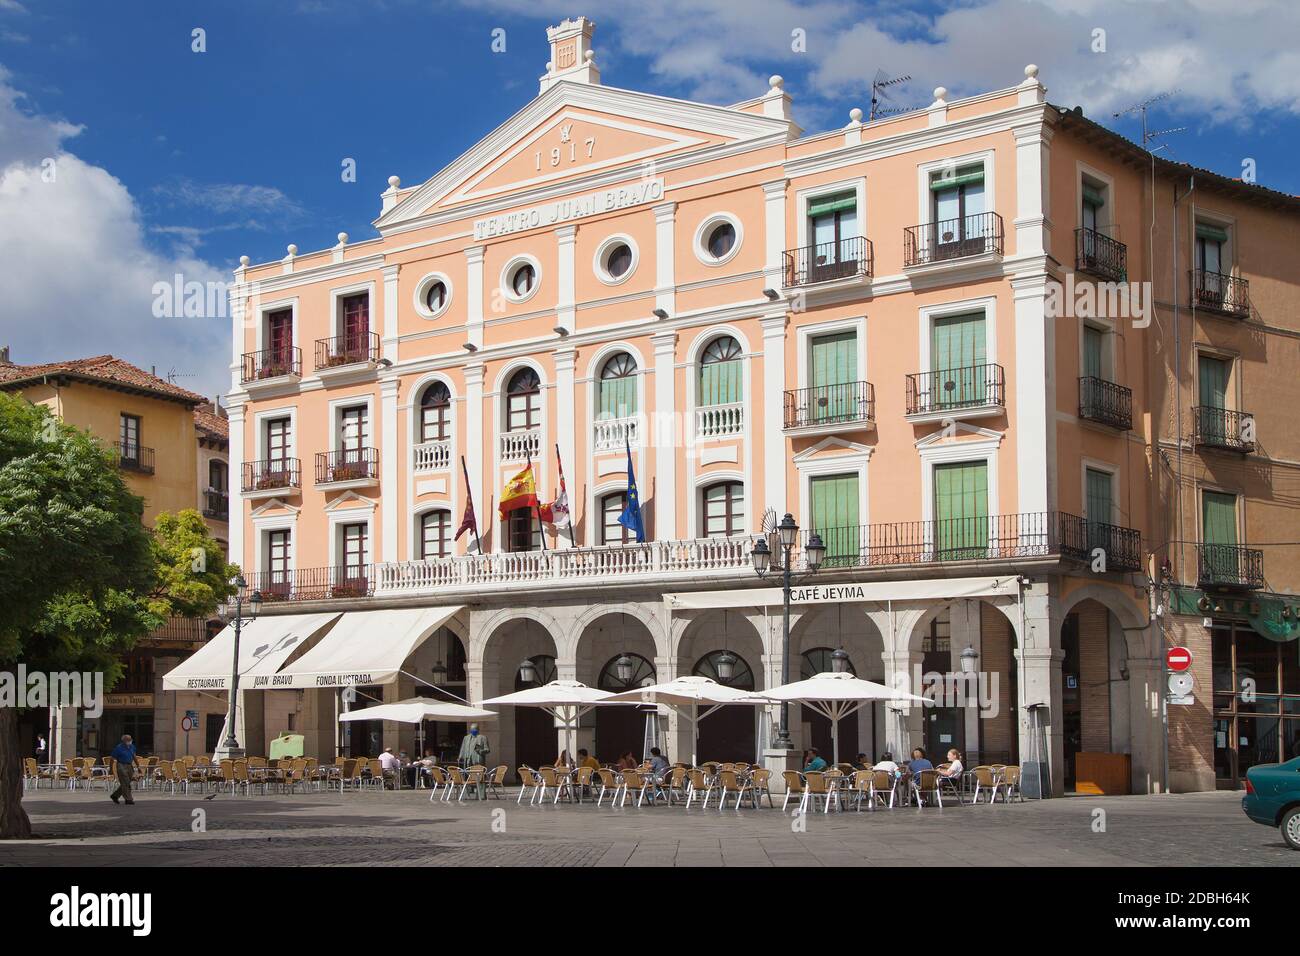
{"left": 274, "top": 605, "right": 462, "bottom": 688}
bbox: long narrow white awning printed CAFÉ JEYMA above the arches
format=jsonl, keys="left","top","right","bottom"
{"left": 663, "top": 575, "right": 1018, "bottom": 610}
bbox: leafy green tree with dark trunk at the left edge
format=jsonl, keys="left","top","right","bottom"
{"left": 0, "top": 394, "right": 233, "bottom": 839}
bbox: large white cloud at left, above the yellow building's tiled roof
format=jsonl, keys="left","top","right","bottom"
{"left": 0, "top": 68, "right": 230, "bottom": 403}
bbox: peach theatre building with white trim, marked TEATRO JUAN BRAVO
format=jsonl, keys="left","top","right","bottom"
{"left": 183, "top": 17, "right": 1300, "bottom": 793}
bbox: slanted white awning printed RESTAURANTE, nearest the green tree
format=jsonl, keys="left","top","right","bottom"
{"left": 163, "top": 614, "right": 338, "bottom": 691}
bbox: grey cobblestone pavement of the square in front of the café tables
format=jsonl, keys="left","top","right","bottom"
{"left": 0, "top": 791, "right": 1300, "bottom": 866}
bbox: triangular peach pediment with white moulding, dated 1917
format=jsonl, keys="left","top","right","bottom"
{"left": 374, "top": 82, "right": 790, "bottom": 232}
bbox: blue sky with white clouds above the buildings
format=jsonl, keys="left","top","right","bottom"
{"left": 0, "top": 0, "right": 1300, "bottom": 393}
